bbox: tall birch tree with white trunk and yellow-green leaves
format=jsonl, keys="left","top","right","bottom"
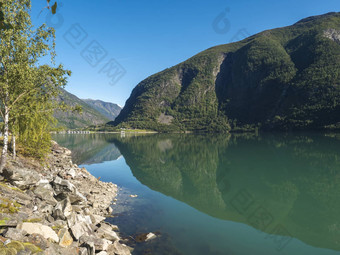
{"left": 0, "top": 0, "right": 70, "bottom": 171}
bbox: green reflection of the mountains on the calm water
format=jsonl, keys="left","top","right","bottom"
{"left": 56, "top": 134, "right": 340, "bottom": 254}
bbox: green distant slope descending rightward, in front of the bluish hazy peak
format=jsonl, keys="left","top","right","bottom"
{"left": 54, "top": 89, "right": 109, "bottom": 129}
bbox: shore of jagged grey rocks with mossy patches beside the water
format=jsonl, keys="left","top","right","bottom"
{"left": 0, "top": 142, "right": 132, "bottom": 255}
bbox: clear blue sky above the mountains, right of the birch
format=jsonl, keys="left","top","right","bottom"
{"left": 32, "top": 0, "right": 340, "bottom": 106}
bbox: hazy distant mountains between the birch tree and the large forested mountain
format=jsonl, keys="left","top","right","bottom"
{"left": 54, "top": 89, "right": 121, "bottom": 129}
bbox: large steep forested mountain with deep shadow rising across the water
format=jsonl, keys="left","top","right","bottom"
{"left": 113, "top": 13, "right": 340, "bottom": 131}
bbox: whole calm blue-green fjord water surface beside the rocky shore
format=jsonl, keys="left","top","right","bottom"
{"left": 54, "top": 134, "right": 340, "bottom": 255}
